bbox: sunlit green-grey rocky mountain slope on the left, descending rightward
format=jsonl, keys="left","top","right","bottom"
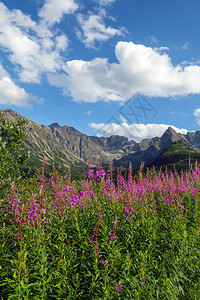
{"left": 0, "top": 109, "right": 117, "bottom": 167}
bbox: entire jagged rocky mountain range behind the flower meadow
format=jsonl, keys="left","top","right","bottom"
{"left": 0, "top": 108, "right": 200, "bottom": 172}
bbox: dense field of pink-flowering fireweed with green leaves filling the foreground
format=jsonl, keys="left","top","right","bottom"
{"left": 0, "top": 165, "right": 200, "bottom": 300}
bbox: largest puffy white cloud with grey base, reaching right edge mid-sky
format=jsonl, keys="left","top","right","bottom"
{"left": 52, "top": 42, "right": 200, "bottom": 102}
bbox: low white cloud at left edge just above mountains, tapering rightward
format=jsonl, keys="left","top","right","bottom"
{"left": 0, "top": 64, "right": 40, "bottom": 107}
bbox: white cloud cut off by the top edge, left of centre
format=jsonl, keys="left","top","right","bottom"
{"left": 39, "top": 0, "right": 78, "bottom": 25}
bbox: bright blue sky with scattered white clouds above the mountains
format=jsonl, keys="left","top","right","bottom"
{"left": 0, "top": 0, "right": 200, "bottom": 142}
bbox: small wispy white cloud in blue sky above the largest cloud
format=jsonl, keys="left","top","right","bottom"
{"left": 77, "top": 14, "right": 124, "bottom": 48}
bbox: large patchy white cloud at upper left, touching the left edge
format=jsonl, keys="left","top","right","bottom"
{"left": 0, "top": 3, "right": 68, "bottom": 83}
